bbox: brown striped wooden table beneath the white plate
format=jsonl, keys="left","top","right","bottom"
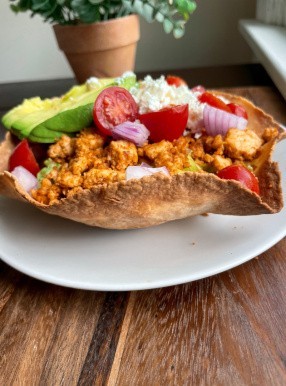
{"left": 0, "top": 66, "right": 286, "bottom": 386}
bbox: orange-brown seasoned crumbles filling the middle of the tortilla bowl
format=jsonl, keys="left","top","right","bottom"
{"left": 32, "top": 128, "right": 278, "bottom": 204}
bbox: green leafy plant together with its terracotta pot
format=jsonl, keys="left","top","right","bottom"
{"left": 10, "top": 0, "right": 196, "bottom": 83}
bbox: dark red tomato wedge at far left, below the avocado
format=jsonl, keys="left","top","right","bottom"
{"left": 8, "top": 139, "right": 40, "bottom": 176}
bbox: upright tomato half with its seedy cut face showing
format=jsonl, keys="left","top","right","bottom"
{"left": 93, "top": 86, "right": 138, "bottom": 135}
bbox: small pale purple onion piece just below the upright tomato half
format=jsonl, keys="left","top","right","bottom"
{"left": 112, "top": 121, "right": 150, "bottom": 146}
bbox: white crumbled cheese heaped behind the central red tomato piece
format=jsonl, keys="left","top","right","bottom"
{"left": 130, "top": 75, "right": 205, "bottom": 131}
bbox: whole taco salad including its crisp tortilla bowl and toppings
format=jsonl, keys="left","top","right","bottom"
{"left": 0, "top": 73, "right": 284, "bottom": 228}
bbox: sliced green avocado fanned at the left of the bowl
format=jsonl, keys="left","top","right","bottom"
{"left": 2, "top": 74, "right": 136, "bottom": 143}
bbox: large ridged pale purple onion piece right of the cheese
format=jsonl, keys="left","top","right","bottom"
{"left": 203, "top": 104, "right": 248, "bottom": 137}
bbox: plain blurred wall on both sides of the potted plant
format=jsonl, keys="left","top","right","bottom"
{"left": 0, "top": 0, "right": 256, "bottom": 83}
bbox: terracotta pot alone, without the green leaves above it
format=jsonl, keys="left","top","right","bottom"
{"left": 53, "top": 15, "right": 140, "bottom": 83}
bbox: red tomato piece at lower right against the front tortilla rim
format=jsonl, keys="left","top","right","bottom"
{"left": 217, "top": 165, "right": 259, "bottom": 194}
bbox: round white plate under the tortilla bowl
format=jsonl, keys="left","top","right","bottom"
{"left": 0, "top": 141, "right": 286, "bottom": 291}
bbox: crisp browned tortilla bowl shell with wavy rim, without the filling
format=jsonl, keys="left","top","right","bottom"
{"left": 0, "top": 91, "right": 285, "bottom": 229}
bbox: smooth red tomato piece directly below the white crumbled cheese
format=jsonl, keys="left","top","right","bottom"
{"left": 139, "top": 104, "right": 189, "bottom": 142}
